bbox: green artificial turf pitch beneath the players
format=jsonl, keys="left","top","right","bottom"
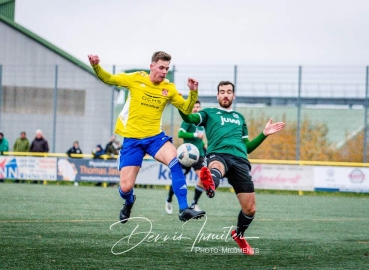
{"left": 0, "top": 183, "right": 369, "bottom": 270}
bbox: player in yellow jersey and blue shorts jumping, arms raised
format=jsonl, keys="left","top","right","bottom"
{"left": 88, "top": 51, "right": 205, "bottom": 223}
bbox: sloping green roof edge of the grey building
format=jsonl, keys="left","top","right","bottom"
{"left": 0, "top": 14, "right": 96, "bottom": 76}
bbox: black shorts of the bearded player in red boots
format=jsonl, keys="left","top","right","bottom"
{"left": 205, "top": 153, "right": 254, "bottom": 194}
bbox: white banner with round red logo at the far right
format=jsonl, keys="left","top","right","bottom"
{"left": 314, "top": 166, "right": 369, "bottom": 192}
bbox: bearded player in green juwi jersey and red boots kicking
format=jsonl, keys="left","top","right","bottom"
{"left": 180, "top": 81, "right": 285, "bottom": 255}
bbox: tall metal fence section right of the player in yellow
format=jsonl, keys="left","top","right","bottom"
{"left": 170, "top": 66, "right": 369, "bottom": 163}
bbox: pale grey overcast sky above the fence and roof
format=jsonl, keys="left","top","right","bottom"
{"left": 15, "top": 0, "right": 369, "bottom": 67}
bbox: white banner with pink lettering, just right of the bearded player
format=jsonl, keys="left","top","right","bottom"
{"left": 251, "top": 164, "right": 314, "bottom": 191}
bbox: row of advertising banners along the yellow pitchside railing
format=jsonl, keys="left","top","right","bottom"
{"left": 0, "top": 156, "right": 369, "bottom": 193}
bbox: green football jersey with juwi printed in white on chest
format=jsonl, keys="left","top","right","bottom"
{"left": 198, "top": 108, "right": 248, "bottom": 158}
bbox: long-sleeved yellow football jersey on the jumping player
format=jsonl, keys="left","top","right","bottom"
{"left": 92, "top": 65, "right": 198, "bottom": 139}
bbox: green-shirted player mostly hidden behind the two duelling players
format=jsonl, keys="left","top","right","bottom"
{"left": 165, "top": 100, "right": 205, "bottom": 215}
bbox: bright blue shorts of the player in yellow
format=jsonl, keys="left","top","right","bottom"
{"left": 117, "top": 132, "right": 172, "bottom": 170}
